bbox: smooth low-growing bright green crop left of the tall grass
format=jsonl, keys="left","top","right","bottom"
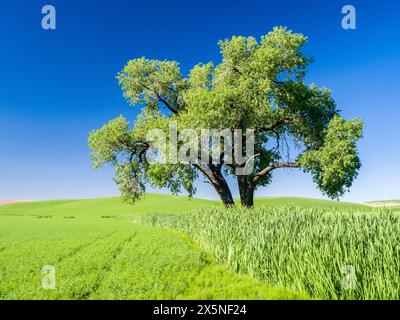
{"left": 0, "top": 197, "right": 307, "bottom": 300}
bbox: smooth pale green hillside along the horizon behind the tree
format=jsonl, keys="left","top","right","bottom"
{"left": 0, "top": 194, "right": 372, "bottom": 217}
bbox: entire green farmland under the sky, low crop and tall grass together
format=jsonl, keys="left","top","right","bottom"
{"left": 0, "top": 195, "right": 400, "bottom": 299}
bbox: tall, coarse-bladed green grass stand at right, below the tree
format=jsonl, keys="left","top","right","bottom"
{"left": 140, "top": 205, "right": 400, "bottom": 300}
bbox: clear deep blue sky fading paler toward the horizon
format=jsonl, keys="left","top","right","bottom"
{"left": 0, "top": 0, "right": 400, "bottom": 201}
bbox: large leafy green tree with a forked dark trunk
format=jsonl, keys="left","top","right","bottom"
{"left": 89, "top": 27, "right": 363, "bottom": 207}
